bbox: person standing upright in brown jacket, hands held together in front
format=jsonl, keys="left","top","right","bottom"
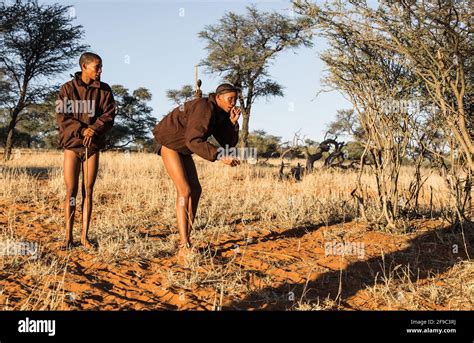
{"left": 56, "top": 52, "right": 115, "bottom": 249}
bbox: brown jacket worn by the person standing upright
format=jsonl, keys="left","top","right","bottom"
{"left": 56, "top": 72, "right": 115, "bottom": 149}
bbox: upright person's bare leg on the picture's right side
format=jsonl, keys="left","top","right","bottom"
{"left": 81, "top": 152, "right": 99, "bottom": 248}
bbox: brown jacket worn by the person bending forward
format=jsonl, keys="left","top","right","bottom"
{"left": 153, "top": 93, "right": 239, "bottom": 161}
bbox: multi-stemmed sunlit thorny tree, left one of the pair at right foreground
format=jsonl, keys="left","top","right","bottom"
{"left": 296, "top": 5, "right": 419, "bottom": 228}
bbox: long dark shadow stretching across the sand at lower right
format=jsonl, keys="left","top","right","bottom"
{"left": 225, "top": 223, "right": 474, "bottom": 310}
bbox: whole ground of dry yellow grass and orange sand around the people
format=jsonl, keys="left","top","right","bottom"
{"left": 0, "top": 150, "right": 474, "bottom": 310}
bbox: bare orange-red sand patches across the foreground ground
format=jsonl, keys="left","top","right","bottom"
{"left": 0, "top": 199, "right": 472, "bottom": 310}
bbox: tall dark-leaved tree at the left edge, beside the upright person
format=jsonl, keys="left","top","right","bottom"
{"left": 0, "top": 0, "right": 87, "bottom": 160}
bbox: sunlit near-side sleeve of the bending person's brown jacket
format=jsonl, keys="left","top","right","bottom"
{"left": 184, "top": 100, "right": 217, "bottom": 162}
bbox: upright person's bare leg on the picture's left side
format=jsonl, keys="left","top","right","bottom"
{"left": 62, "top": 150, "right": 81, "bottom": 249}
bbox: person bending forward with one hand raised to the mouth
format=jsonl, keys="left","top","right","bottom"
{"left": 153, "top": 83, "right": 240, "bottom": 261}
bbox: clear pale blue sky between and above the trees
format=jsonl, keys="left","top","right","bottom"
{"left": 41, "top": 0, "right": 351, "bottom": 141}
